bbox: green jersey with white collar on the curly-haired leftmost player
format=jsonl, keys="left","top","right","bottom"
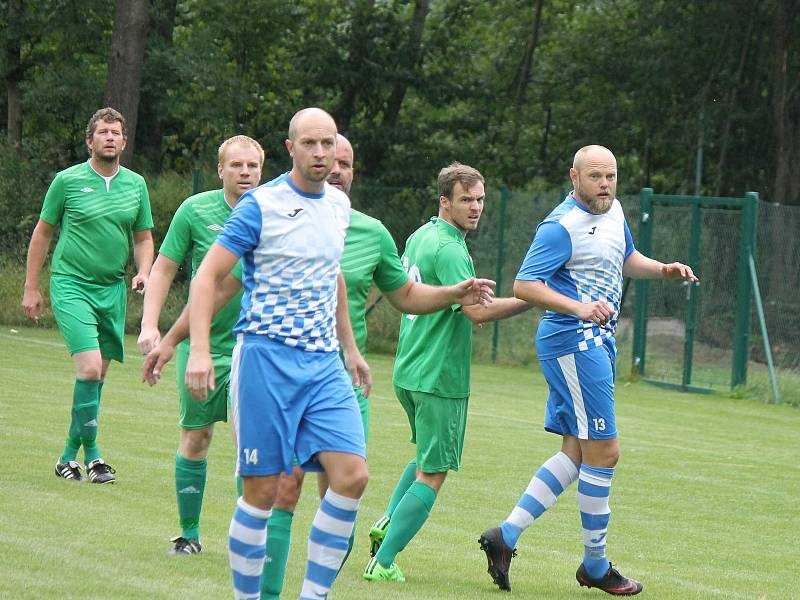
{"left": 40, "top": 159, "right": 153, "bottom": 285}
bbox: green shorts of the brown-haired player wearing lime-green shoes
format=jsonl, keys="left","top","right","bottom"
{"left": 394, "top": 386, "right": 469, "bottom": 473}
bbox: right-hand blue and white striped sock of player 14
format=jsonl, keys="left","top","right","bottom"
{"left": 300, "top": 488, "right": 360, "bottom": 600}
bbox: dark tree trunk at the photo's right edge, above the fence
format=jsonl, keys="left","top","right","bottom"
{"left": 771, "top": 0, "right": 800, "bottom": 204}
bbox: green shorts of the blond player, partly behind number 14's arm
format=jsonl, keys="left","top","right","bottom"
{"left": 175, "top": 344, "right": 231, "bottom": 429}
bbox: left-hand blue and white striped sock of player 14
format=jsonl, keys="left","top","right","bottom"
{"left": 228, "top": 498, "right": 272, "bottom": 600}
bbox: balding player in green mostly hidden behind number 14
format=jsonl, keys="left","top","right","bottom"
{"left": 143, "top": 135, "right": 494, "bottom": 599}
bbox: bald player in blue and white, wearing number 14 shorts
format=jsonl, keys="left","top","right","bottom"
{"left": 186, "top": 108, "right": 371, "bottom": 600}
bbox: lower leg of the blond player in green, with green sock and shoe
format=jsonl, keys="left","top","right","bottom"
{"left": 169, "top": 424, "right": 214, "bottom": 556}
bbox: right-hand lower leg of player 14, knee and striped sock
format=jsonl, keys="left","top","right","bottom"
{"left": 300, "top": 452, "right": 368, "bottom": 600}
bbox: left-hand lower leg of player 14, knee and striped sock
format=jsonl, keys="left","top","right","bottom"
{"left": 228, "top": 475, "right": 278, "bottom": 600}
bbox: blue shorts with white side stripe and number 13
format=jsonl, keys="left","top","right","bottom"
{"left": 540, "top": 338, "right": 617, "bottom": 440}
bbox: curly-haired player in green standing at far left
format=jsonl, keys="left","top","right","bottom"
{"left": 22, "top": 108, "right": 153, "bottom": 483}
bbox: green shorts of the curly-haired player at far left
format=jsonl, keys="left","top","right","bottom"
{"left": 50, "top": 275, "right": 127, "bottom": 362}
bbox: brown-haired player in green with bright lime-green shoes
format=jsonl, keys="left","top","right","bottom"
{"left": 364, "top": 163, "right": 528, "bottom": 581}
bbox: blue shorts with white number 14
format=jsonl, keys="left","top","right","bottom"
{"left": 230, "top": 334, "right": 366, "bottom": 477}
